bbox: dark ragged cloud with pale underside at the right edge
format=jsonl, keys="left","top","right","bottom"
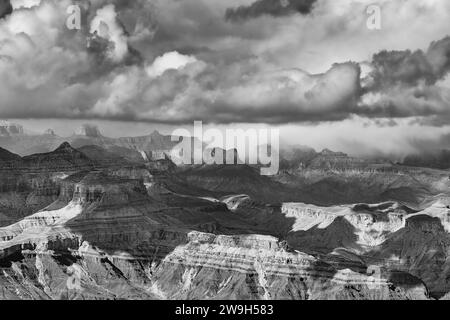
{"left": 360, "top": 37, "right": 450, "bottom": 123}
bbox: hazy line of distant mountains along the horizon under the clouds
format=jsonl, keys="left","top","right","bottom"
{"left": 5, "top": 121, "right": 450, "bottom": 176}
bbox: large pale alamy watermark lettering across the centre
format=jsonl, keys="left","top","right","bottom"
{"left": 170, "top": 121, "right": 280, "bottom": 176}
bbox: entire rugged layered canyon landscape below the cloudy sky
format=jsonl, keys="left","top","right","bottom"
{"left": 0, "top": 124, "right": 450, "bottom": 300}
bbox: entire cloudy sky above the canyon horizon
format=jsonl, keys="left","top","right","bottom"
{"left": 0, "top": 0, "right": 450, "bottom": 156}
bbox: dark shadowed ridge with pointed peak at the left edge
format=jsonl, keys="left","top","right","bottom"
{"left": 0, "top": 143, "right": 152, "bottom": 227}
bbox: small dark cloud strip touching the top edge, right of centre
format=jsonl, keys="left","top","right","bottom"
{"left": 225, "top": 0, "right": 317, "bottom": 21}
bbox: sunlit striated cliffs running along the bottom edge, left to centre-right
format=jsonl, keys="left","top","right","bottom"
{"left": 0, "top": 221, "right": 427, "bottom": 299}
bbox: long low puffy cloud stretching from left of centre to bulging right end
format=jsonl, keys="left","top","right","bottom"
{"left": 86, "top": 55, "right": 360, "bottom": 123}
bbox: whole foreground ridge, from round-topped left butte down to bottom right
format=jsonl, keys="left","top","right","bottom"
{"left": 0, "top": 172, "right": 436, "bottom": 299}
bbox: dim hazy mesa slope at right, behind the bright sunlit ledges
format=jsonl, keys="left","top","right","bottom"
{"left": 273, "top": 150, "right": 450, "bottom": 208}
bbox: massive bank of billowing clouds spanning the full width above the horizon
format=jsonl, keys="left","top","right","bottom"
{"left": 0, "top": 0, "right": 450, "bottom": 127}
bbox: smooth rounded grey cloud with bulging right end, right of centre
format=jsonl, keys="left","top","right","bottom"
{"left": 207, "top": 63, "right": 360, "bottom": 123}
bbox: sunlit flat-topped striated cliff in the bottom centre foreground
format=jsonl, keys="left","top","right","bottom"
{"left": 152, "top": 232, "right": 426, "bottom": 299}
